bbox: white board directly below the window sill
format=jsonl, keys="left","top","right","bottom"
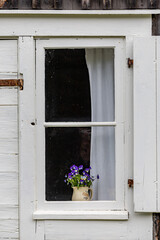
{"left": 45, "top": 221, "right": 128, "bottom": 240}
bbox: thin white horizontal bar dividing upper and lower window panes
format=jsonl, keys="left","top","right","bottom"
{"left": 44, "top": 122, "right": 116, "bottom": 128}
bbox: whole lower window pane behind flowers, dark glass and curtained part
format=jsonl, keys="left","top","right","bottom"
{"left": 46, "top": 127, "right": 115, "bottom": 201}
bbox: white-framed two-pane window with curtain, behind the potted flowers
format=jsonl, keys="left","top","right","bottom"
{"left": 36, "top": 38, "right": 124, "bottom": 210}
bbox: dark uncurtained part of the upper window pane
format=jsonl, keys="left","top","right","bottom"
{"left": 45, "top": 49, "right": 91, "bottom": 122}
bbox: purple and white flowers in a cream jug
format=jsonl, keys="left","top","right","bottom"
{"left": 64, "top": 165, "right": 99, "bottom": 201}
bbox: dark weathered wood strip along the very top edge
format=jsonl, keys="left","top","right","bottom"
{"left": 0, "top": 0, "right": 160, "bottom": 10}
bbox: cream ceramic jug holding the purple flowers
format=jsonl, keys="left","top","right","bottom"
{"left": 72, "top": 187, "right": 93, "bottom": 201}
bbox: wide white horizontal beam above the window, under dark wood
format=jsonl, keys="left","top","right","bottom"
{"left": 0, "top": 14, "right": 152, "bottom": 37}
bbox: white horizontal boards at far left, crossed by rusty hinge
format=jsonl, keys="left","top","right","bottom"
{"left": 0, "top": 40, "right": 19, "bottom": 240}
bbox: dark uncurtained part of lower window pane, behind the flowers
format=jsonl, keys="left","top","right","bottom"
{"left": 46, "top": 128, "right": 91, "bottom": 201}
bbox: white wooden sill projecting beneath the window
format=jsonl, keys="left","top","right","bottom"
{"left": 33, "top": 210, "right": 128, "bottom": 220}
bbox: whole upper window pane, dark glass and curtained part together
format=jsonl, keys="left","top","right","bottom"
{"left": 45, "top": 48, "right": 115, "bottom": 122}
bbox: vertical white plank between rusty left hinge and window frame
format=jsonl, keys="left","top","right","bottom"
{"left": 18, "top": 37, "right": 35, "bottom": 240}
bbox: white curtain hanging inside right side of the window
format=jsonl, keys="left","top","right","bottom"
{"left": 86, "top": 49, "right": 115, "bottom": 200}
